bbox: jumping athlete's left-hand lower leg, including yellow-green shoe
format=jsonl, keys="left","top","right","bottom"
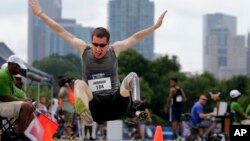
{"left": 74, "top": 80, "right": 93, "bottom": 123}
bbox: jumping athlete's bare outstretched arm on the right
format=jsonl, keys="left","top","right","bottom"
{"left": 114, "top": 11, "right": 167, "bottom": 56}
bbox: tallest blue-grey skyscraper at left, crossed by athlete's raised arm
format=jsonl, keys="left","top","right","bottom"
{"left": 28, "top": 0, "right": 62, "bottom": 64}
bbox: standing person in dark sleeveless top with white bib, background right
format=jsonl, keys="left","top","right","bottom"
{"left": 164, "top": 78, "right": 187, "bottom": 138}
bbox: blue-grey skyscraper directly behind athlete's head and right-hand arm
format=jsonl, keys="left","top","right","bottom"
{"left": 108, "top": 0, "right": 154, "bottom": 59}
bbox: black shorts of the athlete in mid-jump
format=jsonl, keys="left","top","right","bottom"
{"left": 89, "top": 90, "right": 130, "bottom": 122}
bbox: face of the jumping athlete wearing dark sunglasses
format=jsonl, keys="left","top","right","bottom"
{"left": 92, "top": 36, "right": 109, "bottom": 59}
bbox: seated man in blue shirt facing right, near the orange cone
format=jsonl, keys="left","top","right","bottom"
{"left": 190, "top": 95, "right": 216, "bottom": 138}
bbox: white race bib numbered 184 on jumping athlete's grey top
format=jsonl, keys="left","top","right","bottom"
{"left": 88, "top": 77, "right": 111, "bottom": 92}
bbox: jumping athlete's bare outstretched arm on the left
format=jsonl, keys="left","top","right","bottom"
{"left": 29, "top": 0, "right": 86, "bottom": 54}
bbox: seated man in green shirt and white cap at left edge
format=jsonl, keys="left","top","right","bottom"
{"left": 0, "top": 55, "right": 35, "bottom": 138}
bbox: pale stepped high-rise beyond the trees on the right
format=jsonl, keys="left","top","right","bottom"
{"left": 203, "top": 13, "right": 246, "bottom": 79}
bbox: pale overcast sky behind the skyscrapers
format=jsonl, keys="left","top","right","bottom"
{"left": 0, "top": 0, "right": 250, "bottom": 72}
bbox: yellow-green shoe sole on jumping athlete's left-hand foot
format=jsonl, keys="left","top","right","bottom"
{"left": 74, "top": 97, "right": 93, "bottom": 124}
